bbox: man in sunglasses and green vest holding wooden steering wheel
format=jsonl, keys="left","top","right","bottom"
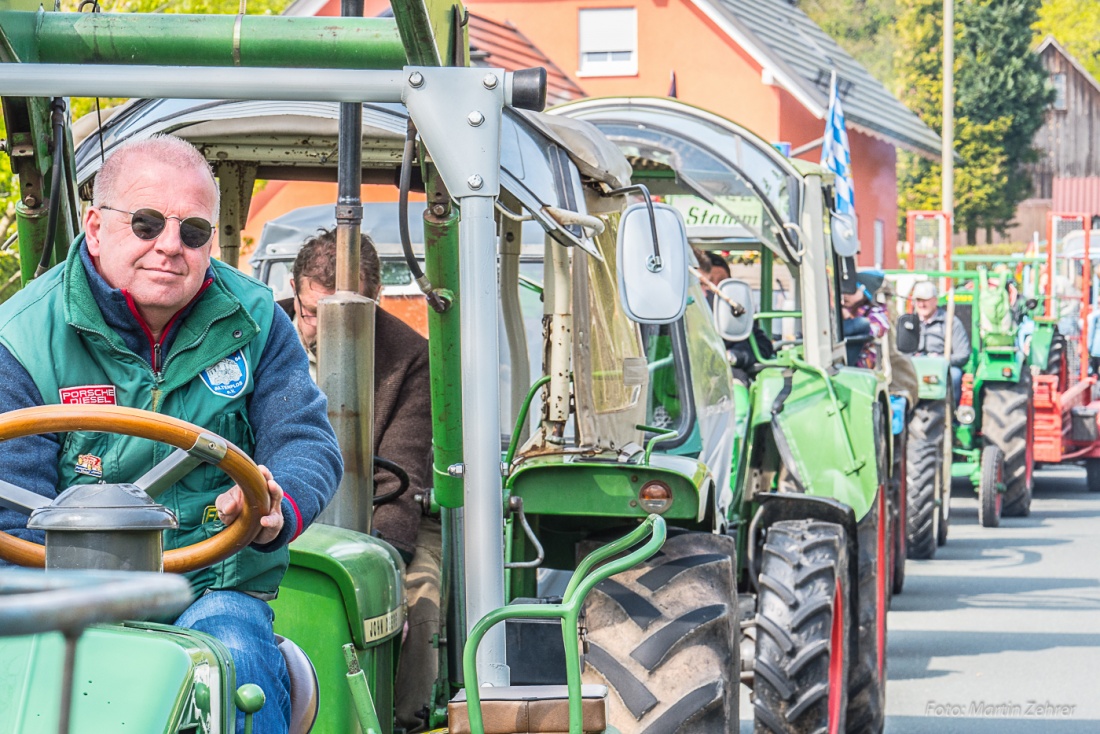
{"left": 0, "top": 136, "right": 343, "bottom": 733}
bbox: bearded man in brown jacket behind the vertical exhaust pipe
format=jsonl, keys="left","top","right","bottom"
{"left": 288, "top": 230, "right": 442, "bottom": 732}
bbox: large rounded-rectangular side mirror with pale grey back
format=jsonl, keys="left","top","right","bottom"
{"left": 617, "top": 204, "right": 689, "bottom": 324}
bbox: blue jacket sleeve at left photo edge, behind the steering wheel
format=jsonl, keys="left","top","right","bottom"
{"left": 0, "top": 347, "right": 61, "bottom": 556}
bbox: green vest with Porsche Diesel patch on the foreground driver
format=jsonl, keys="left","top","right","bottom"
{"left": 0, "top": 235, "right": 279, "bottom": 595}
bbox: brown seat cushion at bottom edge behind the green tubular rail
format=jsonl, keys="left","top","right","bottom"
{"left": 447, "top": 686, "right": 607, "bottom": 734}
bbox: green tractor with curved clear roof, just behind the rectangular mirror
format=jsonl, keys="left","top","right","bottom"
{"left": 558, "top": 98, "right": 892, "bottom": 732}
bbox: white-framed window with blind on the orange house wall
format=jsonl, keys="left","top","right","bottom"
{"left": 576, "top": 8, "right": 638, "bottom": 77}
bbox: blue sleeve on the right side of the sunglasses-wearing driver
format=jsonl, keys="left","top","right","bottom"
{"left": 249, "top": 305, "right": 343, "bottom": 551}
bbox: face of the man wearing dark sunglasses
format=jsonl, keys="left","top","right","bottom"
{"left": 84, "top": 155, "right": 217, "bottom": 326}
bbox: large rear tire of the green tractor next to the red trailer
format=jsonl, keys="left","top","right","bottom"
{"left": 981, "top": 378, "right": 1032, "bottom": 517}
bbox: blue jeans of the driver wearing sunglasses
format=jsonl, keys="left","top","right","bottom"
{"left": 176, "top": 591, "right": 290, "bottom": 734}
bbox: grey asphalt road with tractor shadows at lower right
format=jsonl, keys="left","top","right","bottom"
{"left": 741, "top": 467, "right": 1100, "bottom": 734}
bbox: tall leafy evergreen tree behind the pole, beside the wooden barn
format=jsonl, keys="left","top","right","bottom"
{"left": 897, "top": 0, "right": 1052, "bottom": 243}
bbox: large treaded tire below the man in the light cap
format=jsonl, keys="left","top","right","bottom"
{"left": 905, "top": 401, "right": 947, "bottom": 559}
